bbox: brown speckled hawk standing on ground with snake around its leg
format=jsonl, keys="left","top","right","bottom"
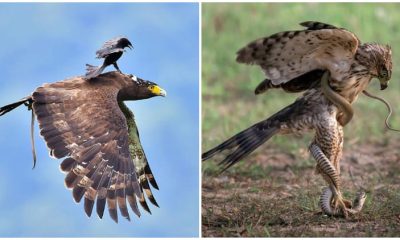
{"left": 202, "top": 22, "right": 392, "bottom": 216}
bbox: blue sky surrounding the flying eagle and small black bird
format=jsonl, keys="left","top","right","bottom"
{"left": 0, "top": 3, "right": 199, "bottom": 237}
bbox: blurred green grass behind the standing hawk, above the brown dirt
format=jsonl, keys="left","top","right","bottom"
{"left": 202, "top": 3, "right": 400, "bottom": 170}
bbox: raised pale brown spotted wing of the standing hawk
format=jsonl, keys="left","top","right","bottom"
{"left": 236, "top": 22, "right": 359, "bottom": 85}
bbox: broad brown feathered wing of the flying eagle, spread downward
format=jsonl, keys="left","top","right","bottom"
{"left": 32, "top": 78, "right": 155, "bottom": 221}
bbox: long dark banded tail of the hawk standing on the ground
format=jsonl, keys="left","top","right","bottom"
{"left": 201, "top": 99, "right": 304, "bottom": 172}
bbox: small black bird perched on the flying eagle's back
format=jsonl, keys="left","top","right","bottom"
{"left": 85, "top": 37, "right": 133, "bottom": 79}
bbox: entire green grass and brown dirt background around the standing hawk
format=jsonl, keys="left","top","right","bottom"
{"left": 202, "top": 3, "right": 400, "bottom": 236}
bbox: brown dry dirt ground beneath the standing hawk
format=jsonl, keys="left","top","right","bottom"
{"left": 202, "top": 143, "right": 400, "bottom": 237}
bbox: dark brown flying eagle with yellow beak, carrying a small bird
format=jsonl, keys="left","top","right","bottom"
{"left": 0, "top": 72, "right": 166, "bottom": 222}
